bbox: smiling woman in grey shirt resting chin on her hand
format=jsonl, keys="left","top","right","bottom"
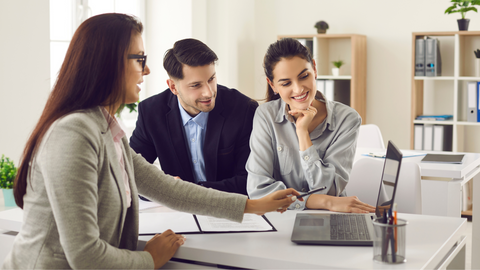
{"left": 246, "top": 38, "right": 375, "bottom": 213}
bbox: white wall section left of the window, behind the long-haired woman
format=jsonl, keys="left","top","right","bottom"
{"left": 0, "top": 0, "right": 50, "bottom": 164}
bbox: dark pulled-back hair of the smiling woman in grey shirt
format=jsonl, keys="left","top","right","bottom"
{"left": 263, "top": 38, "right": 313, "bottom": 102}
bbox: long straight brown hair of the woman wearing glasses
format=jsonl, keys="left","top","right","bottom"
{"left": 13, "top": 13, "right": 143, "bottom": 208}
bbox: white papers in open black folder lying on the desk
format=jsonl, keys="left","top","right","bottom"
{"left": 139, "top": 212, "right": 276, "bottom": 235}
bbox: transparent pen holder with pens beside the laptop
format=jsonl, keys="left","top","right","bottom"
{"left": 373, "top": 219, "right": 408, "bottom": 263}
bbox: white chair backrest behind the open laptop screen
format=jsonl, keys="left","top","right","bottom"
{"left": 346, "top": 157, "right": 422, "bottom": 214}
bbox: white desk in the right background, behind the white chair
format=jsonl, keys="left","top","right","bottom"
{"left": 355, "top": 148, "right": 480, "bottom": 269}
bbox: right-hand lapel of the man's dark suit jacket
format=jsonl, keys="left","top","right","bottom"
{"left": 203, "top": 91, "right": 225, "bottom": 181}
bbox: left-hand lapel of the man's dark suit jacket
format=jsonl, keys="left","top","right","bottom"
{"left": 165, "top": 95, "right": 195, "bottom": 182}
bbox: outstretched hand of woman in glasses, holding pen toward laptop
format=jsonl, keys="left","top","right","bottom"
{"left": 245, "top": 188, "right": 303, "bottom": 215}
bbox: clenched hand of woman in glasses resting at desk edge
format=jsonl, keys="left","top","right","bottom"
{"left": 143, "top": 230, "right": 185, "bottom": 269}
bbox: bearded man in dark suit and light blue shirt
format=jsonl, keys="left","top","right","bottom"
{"left": 130, "top": 39, "right": 258, "bottom": 194}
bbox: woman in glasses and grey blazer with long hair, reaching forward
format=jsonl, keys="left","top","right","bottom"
{"left": 3, "top": 14, "right": 298, "bottom": 269}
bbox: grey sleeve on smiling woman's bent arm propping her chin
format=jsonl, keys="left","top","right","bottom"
{"left": 299, "top": 114, "right": 362, "bottom": 197}
